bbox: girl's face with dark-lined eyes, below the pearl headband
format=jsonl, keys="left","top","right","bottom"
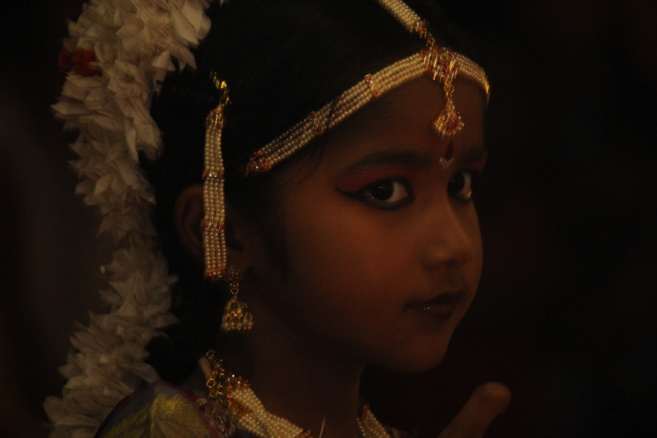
{"left": 243, "top": 78, "right": 485, "bottom": 371}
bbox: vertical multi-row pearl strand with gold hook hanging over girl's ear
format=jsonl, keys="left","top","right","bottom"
{"left": 203, "top": 73, "right": 230, "bottom": 280}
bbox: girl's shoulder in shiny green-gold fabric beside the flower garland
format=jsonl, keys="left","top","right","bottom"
{"left": 96, "top": 381, "right": 249, "bottom": 438}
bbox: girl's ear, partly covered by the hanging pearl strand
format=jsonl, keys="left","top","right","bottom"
{"left": 174, "top": 184, "right": 257, "bottom": 272}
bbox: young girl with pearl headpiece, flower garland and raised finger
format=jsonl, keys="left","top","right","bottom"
{"left": 46, "top": 0, "right": 509, "bottom": 438}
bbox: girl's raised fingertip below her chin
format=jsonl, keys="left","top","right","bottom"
{"left": 438, "top": 382, "right": 511, "bottom": 438}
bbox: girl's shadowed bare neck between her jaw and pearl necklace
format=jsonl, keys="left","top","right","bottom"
{"left": 220, "top": 321, "right": 364, "bottom": 438}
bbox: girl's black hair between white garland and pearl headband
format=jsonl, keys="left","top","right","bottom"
{"left": 144, "top": 0, "right": 472, "bottom": 383}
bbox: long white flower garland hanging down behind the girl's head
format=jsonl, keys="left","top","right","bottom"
{"left": 45, "top": 0, "right": 219, "bottom": 437}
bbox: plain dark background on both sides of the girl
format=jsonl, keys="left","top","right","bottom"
{"left": 0, "top": 0, "right": 657, "bottom": 437}
